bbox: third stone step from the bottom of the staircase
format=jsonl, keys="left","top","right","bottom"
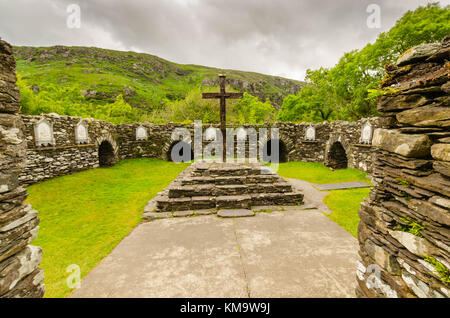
{"left": 181, "top": 174, "right": 283, "bottom": 186}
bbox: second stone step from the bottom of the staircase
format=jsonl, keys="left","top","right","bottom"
{"left": 168, "top": 182, "right": 292, "bottom": 198}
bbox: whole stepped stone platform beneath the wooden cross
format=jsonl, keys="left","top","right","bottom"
{"left": 144, "top": 162, "right": 303, "bottom": 218}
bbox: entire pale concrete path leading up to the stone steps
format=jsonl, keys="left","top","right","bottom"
{"left": 72, "top": 206, "right": 358, "bottom": 297}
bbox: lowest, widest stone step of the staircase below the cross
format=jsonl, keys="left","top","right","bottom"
{"left": 155, "top": 192, "right": 303, "bottom": 212}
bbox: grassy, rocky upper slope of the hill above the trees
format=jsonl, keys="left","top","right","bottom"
{"left": 14, "top": 46, "right": 303, "bottom": 110}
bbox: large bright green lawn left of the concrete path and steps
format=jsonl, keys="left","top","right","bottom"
{"left": 27, "top": 159, "right": 188, "bottom": 297}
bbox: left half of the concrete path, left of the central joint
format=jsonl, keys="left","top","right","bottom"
{"left": 72, "top": 215, "right": 248, "bottom": 298}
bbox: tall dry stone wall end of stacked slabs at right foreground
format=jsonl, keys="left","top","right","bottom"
{"left": 356, "top": 37, "right": 450, "bottom": 297}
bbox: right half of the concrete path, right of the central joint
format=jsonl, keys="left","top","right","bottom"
{"left": 236, "top": 207, "right": 358, "bottom": 297}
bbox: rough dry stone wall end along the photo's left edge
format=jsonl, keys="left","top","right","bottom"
{"left": 0, "top": 39, "right": 45, "bottom": 298}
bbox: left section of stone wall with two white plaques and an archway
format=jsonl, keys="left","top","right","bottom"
{"left": 19, "top": 114, "right": 118, "bottom": 184}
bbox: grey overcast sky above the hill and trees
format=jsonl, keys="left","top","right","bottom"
{"left": 0, "top": 0, "right": 450, "bottom": 80}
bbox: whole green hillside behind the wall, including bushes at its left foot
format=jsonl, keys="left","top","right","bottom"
{"left": 14, "top": 46, "right": 303, "bottom": 121}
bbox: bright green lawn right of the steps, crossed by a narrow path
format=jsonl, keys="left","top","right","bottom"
{"left": 278, "top": 162, "right": 370, "bottom": 237}
